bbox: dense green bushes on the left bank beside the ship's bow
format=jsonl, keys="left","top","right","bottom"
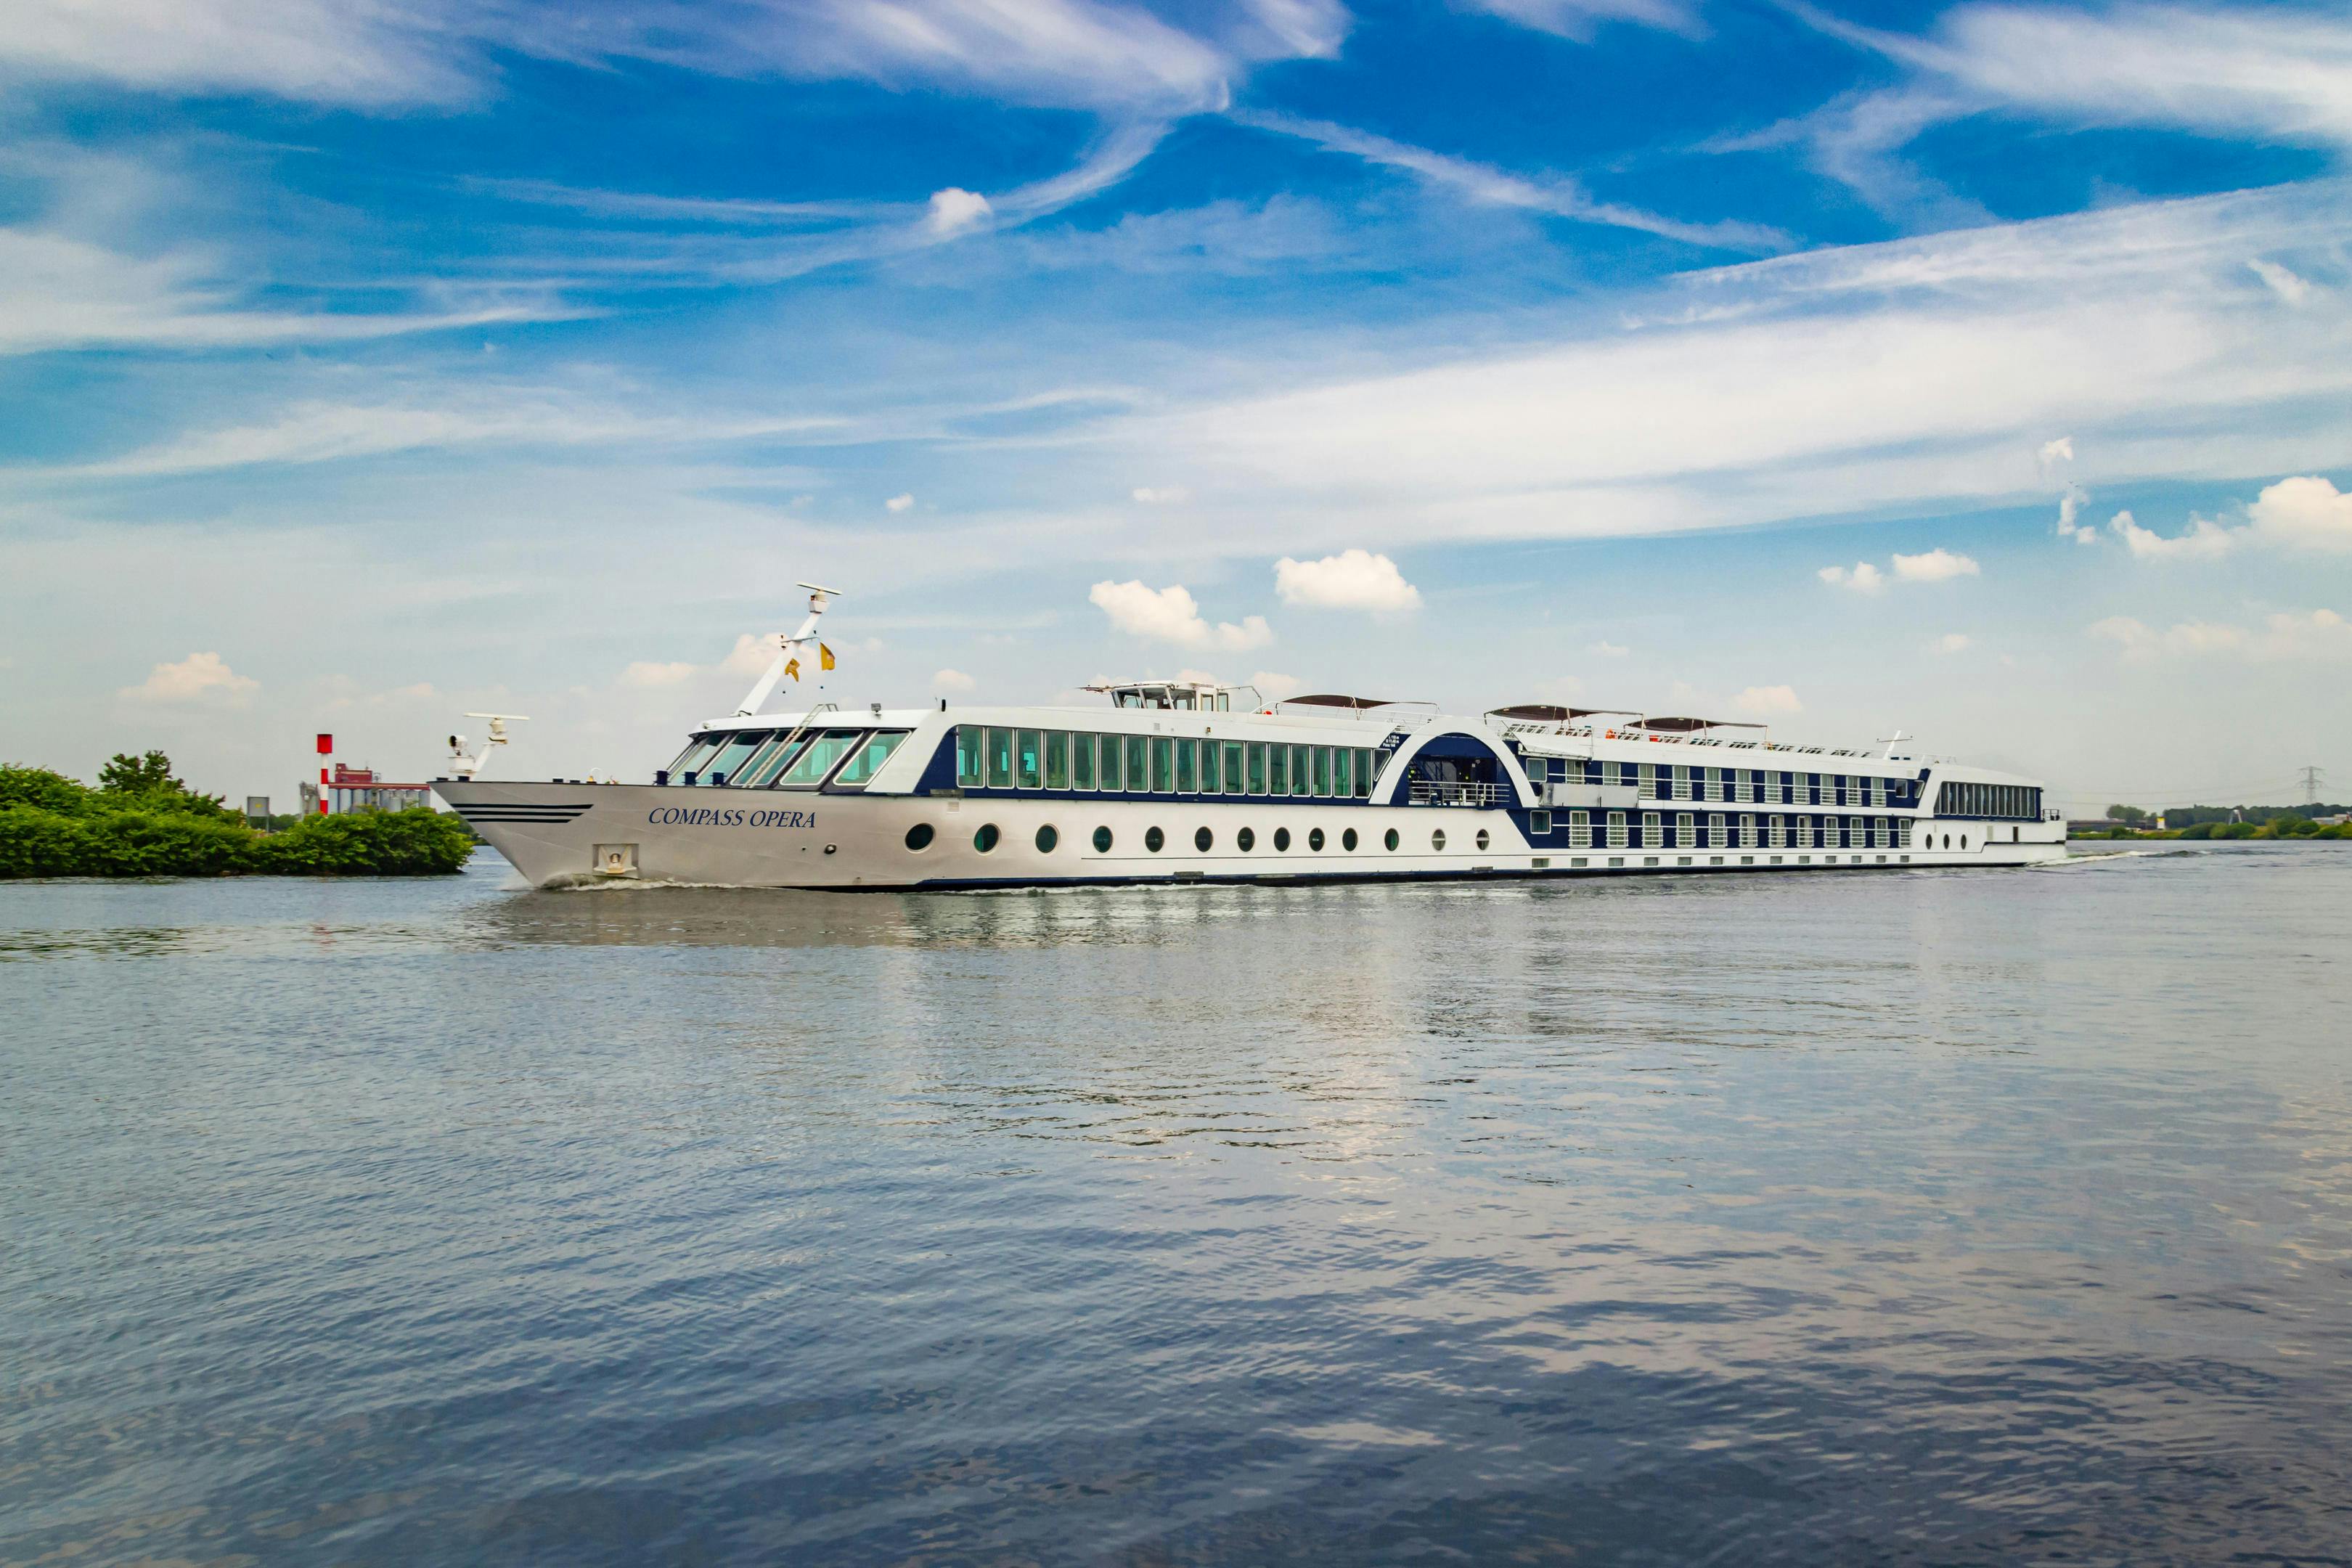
{"left": 0, "top": 752, "right": 475, "bottom": 881}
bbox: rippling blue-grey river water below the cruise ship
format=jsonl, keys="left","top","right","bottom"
{"left": 0, "top": 844, "right": 2352, "bottom": 1568}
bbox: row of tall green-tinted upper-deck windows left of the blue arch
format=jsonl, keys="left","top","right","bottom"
{"left": 955, "top": 724, "right": 1379, "bottom": 799}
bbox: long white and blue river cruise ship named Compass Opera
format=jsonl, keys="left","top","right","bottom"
{"left": 433, "top": 590, "right": 2065, "bottom": 889}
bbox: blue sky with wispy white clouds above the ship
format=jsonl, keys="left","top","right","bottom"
{"left": 0, "top": 0, "right": 2352, "bottom": 807}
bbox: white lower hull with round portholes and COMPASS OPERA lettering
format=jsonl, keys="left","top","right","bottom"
{"left": 435, "top": 780, "right": 2065, "bottom": 889}
